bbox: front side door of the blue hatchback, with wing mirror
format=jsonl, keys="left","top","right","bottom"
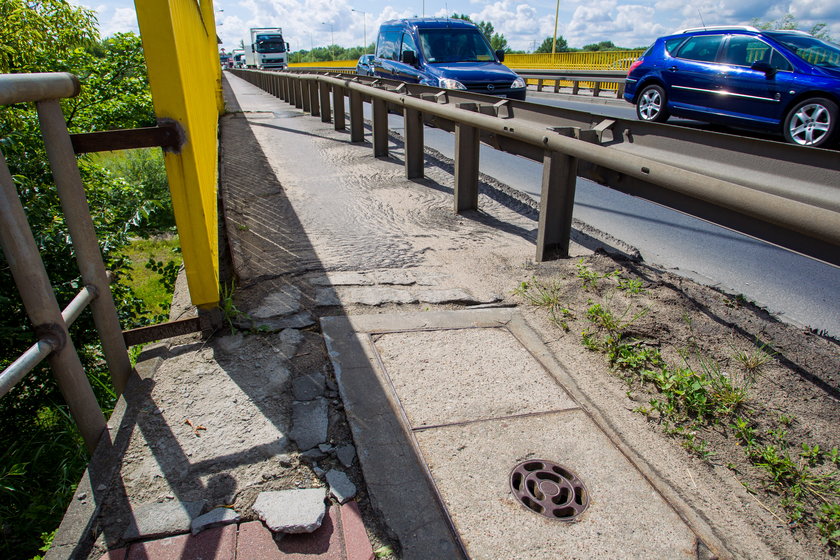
{"left": 718, "top": 35, "right": 794, "bottom": 125}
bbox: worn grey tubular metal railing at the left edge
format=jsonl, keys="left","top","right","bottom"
{"left": 0, "top": 73, "right": 131, "bottom": 452}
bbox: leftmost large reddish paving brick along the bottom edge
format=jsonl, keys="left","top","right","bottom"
{"left": 126, "top": 525, "right": 236, "bottom": 560}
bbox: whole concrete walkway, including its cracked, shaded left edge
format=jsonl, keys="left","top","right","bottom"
{"left": 47, "top": 73, "right": 728, "bottom": 560}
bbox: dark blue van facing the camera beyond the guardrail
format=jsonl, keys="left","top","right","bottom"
{"left": 373, "top": 18, "right": 526, "bottom": 100}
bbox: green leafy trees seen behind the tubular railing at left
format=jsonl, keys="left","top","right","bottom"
{"left": 0, "top": 0, "right": 168, "bottom": 559}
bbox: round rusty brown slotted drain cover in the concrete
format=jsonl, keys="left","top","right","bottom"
{"left": 510, "top": 459, "right": 589, "bottom": 521}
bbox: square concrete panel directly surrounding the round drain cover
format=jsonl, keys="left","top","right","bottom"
{"left": 415, "top": 410, "right": 697, "bottom": 560}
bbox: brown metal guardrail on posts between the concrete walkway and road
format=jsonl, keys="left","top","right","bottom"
{"left": 233, "top": 70, "right": 840, "bottom": 266}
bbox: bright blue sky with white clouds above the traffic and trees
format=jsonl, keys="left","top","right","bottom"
{"left": 79, "top": 0, "right": 840, "bottom": 52}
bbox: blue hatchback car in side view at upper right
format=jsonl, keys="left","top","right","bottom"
{"left": 624, "top": 27, "right": 840, "bottom": 146}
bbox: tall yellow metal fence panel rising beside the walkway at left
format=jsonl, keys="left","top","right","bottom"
{"left": 135, "top": 0, "right": 224, "bottom": 308}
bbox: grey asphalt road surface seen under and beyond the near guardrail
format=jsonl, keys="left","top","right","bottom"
{"left": 368, "top": 92, "right": 840, "bottom": 338}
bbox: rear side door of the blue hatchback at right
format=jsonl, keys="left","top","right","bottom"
{"left": 662, "top": 35, "right": 724, "bottom": 118}
